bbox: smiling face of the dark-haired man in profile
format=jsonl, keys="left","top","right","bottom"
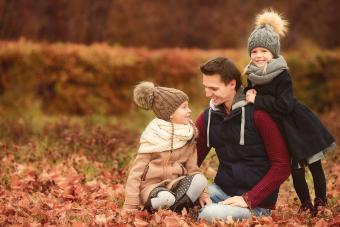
{"left": 203, "top": 74, "right": 236, "bottom": 106}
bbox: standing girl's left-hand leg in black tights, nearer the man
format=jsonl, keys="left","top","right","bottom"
{"left": 292, "top": 167, "right": 313, "bottom": 212}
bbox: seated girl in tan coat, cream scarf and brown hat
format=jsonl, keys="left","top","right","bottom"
{"left": 123, "top": 82, "right": 210, "bottom": 212}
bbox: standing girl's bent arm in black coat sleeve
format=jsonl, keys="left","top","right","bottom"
{"left": 254, "top": 73, "right": 295, "bottom": 114}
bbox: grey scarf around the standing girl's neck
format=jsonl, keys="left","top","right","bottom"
{"left": 247, "top": 55, "right": 288, "bottom": 85}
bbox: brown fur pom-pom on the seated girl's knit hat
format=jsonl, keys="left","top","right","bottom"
{"left": 133, "top": 82, "right": 155, "bottom": 110}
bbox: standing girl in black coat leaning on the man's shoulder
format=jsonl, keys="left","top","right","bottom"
{"left": 246, "top": 11, "right": 335, "bottom": 215}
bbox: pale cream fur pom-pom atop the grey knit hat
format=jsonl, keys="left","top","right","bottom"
{"left": 255, "top": 9, "right": 288, "bottom": 37}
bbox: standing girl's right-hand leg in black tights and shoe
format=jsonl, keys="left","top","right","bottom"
{"left": 308, "top": 160, "right": 327, "bottom": 213}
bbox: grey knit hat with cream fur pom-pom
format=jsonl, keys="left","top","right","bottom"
{"left": 248, "top": 10, "right": 288, "bottom": 58}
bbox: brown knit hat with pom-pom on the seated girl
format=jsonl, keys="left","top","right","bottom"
{"left": 133, "top": 82, "right": 189, "bottom": 121}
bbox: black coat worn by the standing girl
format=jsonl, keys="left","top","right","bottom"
{"left": 248, "top": 70, "right": 334, "bottom": 161}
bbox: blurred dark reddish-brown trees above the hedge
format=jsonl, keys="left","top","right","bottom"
{"left": 0, "top": 0, "right": 340, "bottom": 48}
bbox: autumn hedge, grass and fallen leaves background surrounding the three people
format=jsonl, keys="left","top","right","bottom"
{"left": 0, "top": 0, "right": 340, "bottom": 226}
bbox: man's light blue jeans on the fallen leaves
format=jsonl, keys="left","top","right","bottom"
{"left": 198, "top": 183, "right": 270, "bottom": 222}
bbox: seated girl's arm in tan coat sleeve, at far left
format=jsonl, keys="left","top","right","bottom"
{"left": 123, "top": 154, "right": 151, "bottom": 209}
